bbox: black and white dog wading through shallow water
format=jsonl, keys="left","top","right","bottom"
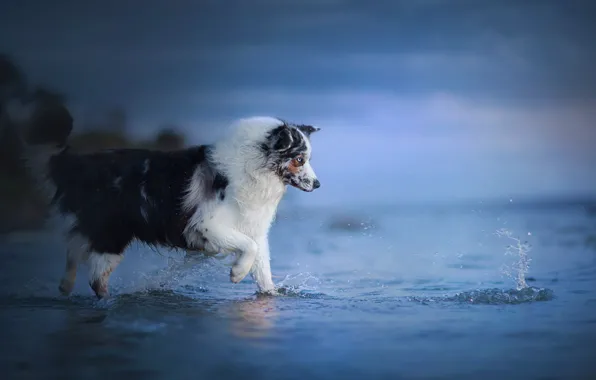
{"left": 8, "top": 102, "right": 320, "bottom": 298}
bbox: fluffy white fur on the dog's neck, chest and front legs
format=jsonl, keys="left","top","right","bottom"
{"left": 184, "top": 117, "right": 286, "bottom": 292}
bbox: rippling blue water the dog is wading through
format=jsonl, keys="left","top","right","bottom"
{"left": 0, "top": 200, "right": 596, "bottom": 380}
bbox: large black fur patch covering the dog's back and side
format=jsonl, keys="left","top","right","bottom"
{"left": 49, "top": 146, "right": 228, "bottom": 254}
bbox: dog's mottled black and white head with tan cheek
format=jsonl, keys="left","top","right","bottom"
{"left": 262, "top": 120, "right": 321, "bottom": 192}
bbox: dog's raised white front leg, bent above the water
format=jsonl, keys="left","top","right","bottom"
{"left": 204, "top": 226, "right": 258, "bottom": 283}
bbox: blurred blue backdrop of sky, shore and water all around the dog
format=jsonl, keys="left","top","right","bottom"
{"left": 0, "top": 0, "right": 596, "bottom": 380}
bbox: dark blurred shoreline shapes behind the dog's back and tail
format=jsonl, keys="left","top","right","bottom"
{"left": 0, "top": 54, "right": 186, "bottom": 234}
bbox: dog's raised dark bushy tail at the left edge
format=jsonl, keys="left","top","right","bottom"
{"left": 0, "top": 100, "right": 73, "bottom": 200}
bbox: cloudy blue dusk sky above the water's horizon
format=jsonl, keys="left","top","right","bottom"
{"left": 0, "top": 0, "right": 596, "bottom": 203}
